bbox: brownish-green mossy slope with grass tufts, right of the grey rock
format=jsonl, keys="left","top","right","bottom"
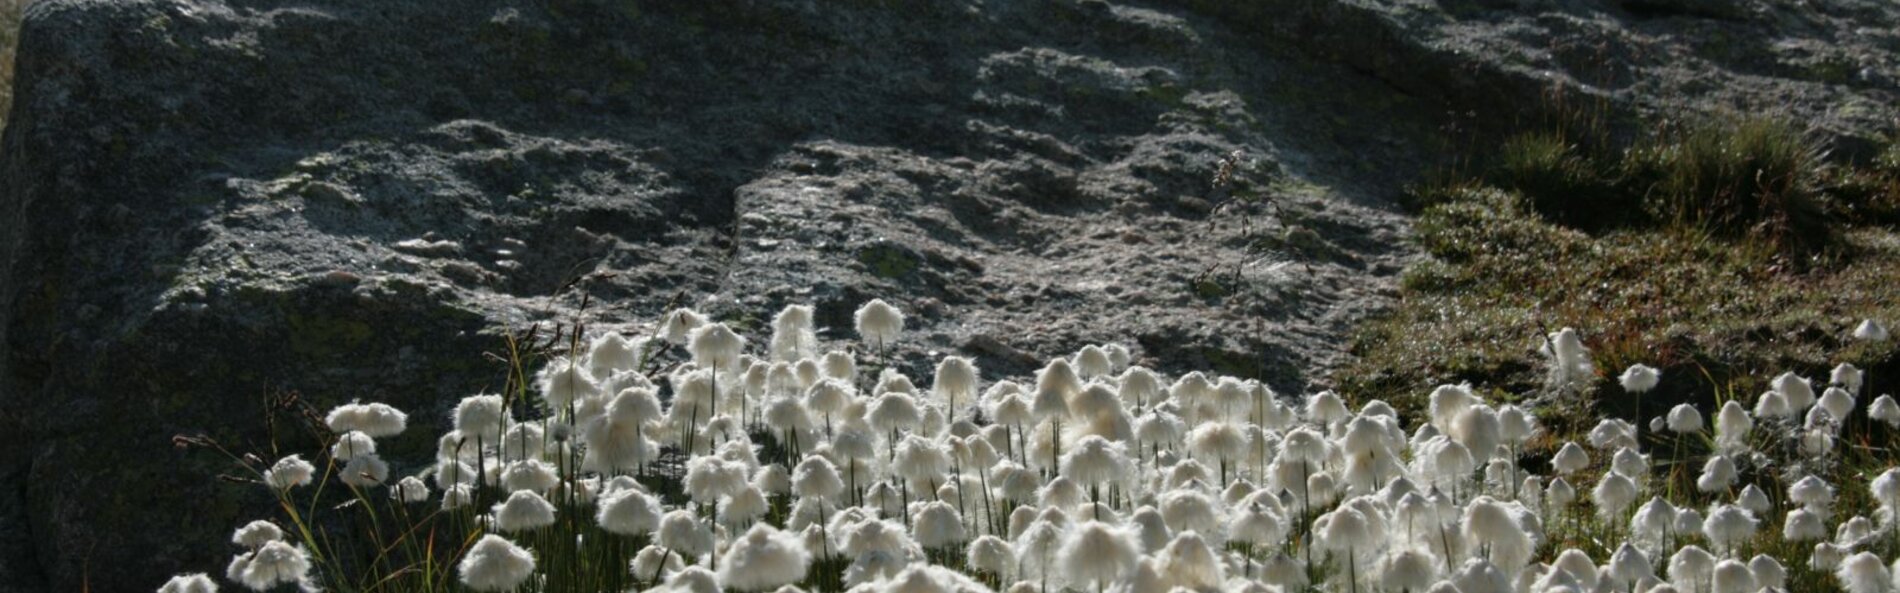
{"left": 1338, "top": 120, "right": 1900, "bottom": 430}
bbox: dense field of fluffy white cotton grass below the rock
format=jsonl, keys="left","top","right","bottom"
{"left": 158, "top": 294, "right": 1900, "bottom": 593}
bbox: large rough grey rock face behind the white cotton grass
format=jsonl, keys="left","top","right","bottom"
{"left": 0, "top": 0, "right": 1900, "bottom": 591}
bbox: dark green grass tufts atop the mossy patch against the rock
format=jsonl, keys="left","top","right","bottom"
{"left": 1466, "top": 118, "right": 1839, "bottom": 257}
